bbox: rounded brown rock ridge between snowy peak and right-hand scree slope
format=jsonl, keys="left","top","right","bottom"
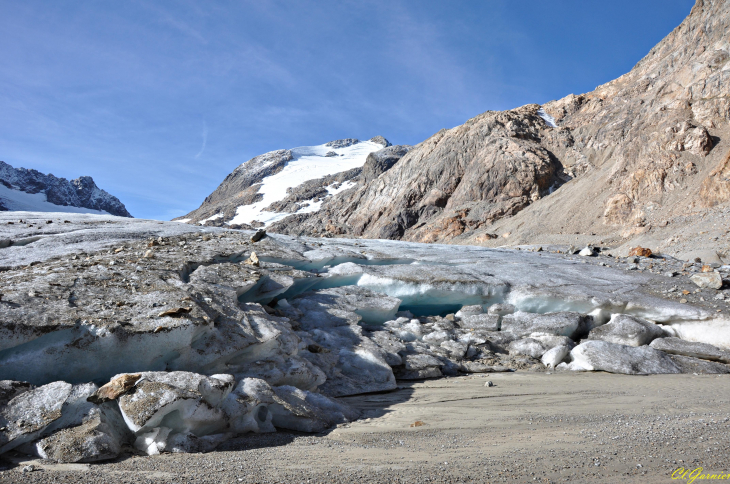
{"left": 273, "top": 105, "right": 568, "bottom": 242}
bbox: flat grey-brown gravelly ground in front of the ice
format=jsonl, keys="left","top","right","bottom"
{"left": 7, "top": 372, "right": 730, "bottom": 484}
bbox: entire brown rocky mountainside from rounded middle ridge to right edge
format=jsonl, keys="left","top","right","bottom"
{"left": 266, "top": 0, "right": 730, "bottom": 260}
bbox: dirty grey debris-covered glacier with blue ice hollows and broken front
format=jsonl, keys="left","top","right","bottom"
{"left": 0, "top": 213, "right": 730, "bottom": 462}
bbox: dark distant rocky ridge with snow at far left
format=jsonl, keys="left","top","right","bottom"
{"left": 0, "top": 161, "right": 132, "bottom": 217}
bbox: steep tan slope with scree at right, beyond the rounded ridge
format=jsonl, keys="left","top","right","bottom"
{"left": 474, "top": 0, "right": 730, "bottom": 259}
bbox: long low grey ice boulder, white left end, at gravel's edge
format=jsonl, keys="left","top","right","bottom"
{"left": 570, "top": 341, "right": 680, "bottom": 375}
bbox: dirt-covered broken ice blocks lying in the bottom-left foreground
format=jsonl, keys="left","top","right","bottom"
{"left": 6, "top": 372, "right": 359, "bottom": 462}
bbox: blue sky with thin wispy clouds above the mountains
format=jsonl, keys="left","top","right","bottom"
{"left": 0, "top": 0, "right": 694, "bottom": 220}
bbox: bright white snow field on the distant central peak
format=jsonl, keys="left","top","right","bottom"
{"left": 228, "top": 141, "right": 383, "bottom": 226}
